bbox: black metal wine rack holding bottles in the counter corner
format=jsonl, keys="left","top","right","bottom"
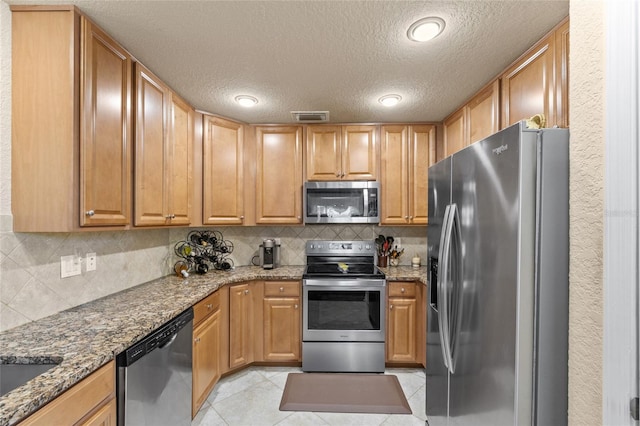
{"left": 173, "top": 231, "right": 233, "bottom": 278}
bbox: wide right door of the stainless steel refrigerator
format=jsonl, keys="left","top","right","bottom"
{"left": 444, "top": 126, "right": 535, "bottom": 426}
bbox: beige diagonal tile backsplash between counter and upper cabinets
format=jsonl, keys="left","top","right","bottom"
{"left": 0, "top": 215, "right": 426, "bottom": 331}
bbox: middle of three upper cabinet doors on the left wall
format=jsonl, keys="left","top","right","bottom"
{"left": 134, "top": 63, "right": 169, "bottom": 226}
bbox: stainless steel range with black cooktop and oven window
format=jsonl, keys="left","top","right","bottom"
{"left": 302, "top": 240, "right": 386, "bottom": 373}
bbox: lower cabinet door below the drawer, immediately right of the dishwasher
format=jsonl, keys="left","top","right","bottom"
{"left": 191, "top": 310, "right": 221, "bottom": 418}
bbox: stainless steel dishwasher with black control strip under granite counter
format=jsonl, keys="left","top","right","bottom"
{"left": 116, "top": 308, "right": 193, "bottom": 426}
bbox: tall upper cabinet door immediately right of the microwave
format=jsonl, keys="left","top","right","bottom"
{"left": 380, "top": 126, "right": 409, "bottom": 225}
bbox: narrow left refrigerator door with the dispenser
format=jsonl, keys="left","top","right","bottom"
{"left": 426, "top": 158, "right": 451, "bottom": 426}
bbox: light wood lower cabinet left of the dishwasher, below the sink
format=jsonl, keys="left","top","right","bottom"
{"left": 20, "top": 361, "right": 117, "bottom": 426}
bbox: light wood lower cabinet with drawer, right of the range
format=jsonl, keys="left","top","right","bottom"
{"left": 386, "top": 281, "right": 422, "bottom": 364}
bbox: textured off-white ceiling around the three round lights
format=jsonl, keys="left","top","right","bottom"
{"left": 5, "top": 0, "right": 569, "bottom": 123}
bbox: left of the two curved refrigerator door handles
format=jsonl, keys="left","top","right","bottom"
{"left": 438, "top": 204, "right": 453, "bottom": 371}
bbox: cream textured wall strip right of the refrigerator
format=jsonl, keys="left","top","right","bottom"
{"left": 569, "top": 0, "right": 605, "bottom": 426}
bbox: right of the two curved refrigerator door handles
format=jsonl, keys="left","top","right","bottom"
{"left": 447, "top": 204, "right": 463, "bottom": 374}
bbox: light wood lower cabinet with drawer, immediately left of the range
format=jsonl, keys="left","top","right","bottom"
{"left": 263, "top": 281, "right": 302, "bottom": 361}
